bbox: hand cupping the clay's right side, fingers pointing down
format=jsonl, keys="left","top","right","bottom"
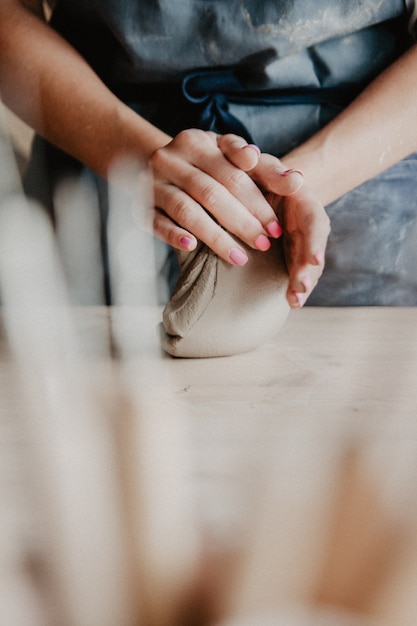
{"left": 218, "top": 135, "right": 330, "bottom": 308}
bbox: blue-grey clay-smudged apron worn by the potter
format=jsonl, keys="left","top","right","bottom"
{"left": 26, "top": 0, "right": 417, "bottom": 306}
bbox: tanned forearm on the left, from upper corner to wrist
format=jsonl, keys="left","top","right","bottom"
{"left": 0, "top": 0, "right": 170, "bottom": 176}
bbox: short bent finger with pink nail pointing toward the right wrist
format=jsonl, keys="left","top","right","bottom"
{"left": 251, "top": 152, "right": 304, "bottom": 196}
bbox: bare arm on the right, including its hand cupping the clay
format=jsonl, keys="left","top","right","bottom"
{"left": 223, "top": 45, "right": 417, "bottom": 307}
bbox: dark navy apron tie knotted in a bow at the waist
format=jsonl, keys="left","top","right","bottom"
{"left": 111, "top": 49, "right": 364, "bottom": 143}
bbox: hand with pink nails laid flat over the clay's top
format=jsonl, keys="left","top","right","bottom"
{"left": 149, "top": 129, "right": 300, "bottom": 265}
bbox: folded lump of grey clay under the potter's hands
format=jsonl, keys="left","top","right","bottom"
{"left": 161, "top": 241, "right": 289, "bottom": 358}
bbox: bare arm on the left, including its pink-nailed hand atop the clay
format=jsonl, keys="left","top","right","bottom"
{"left": 0, "top": 0, "right": 306, "bottom": 265}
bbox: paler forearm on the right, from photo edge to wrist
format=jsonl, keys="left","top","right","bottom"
{"left": 283, "top": 46, "right": 417, "bottom": 205}
